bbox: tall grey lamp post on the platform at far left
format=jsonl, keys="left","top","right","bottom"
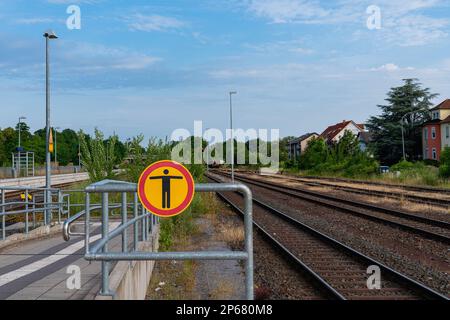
{"left": 44, "top": 30, "right": 58, "bottom": 224}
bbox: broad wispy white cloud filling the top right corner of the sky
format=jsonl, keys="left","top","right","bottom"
{"left": 241, "top": 0, "right": 450, "bottom": 46}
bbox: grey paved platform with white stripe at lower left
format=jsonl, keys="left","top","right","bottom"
{"left": 0, "top": 222, "right": 124, "bottom": 300}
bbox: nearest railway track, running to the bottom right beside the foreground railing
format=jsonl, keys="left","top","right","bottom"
{"left": 208, "top": 176, "right": 448, "bottom": 300}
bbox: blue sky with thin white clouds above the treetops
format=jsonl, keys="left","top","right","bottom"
{"left": 0, "top": 0, "right": 450, "bottom": 139}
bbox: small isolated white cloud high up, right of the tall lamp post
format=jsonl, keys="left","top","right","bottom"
{"left": 127, "top": 14, "right": 188, "bottom": 32}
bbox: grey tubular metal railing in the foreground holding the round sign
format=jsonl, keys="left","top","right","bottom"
{"left": 80, "top": 181, "right": 254, "bottom": 300}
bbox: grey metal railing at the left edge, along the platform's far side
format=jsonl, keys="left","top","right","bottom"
{"left": 0, "top": 186, "right": 63, "bottom": 240}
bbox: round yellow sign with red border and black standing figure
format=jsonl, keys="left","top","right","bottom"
{"left": 138, "top": 160, "right": 195, "bottom": 218}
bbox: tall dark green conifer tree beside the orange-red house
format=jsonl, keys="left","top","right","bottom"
{"left": 367, "top": 79, "right": 438, "bottom": 164}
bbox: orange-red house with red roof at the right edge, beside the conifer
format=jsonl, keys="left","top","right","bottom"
{"left": 422, "top": 99, "right": 450, "bottom": 161}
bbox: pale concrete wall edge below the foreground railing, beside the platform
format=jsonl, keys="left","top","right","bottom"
{"left": 95, "top": 227, "right": 159, "bottom": 300}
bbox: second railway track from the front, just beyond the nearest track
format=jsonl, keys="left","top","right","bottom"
{"left": 209, "top": 172, "right": 450, "bottom": 244}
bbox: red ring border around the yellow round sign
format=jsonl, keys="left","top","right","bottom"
{"left": 138, "top": 160, "right": 194, "bottom": 218}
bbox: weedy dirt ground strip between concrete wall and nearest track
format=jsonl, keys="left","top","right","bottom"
{"left": 147, "top": 206, "right": 245, "bottom": 300}
